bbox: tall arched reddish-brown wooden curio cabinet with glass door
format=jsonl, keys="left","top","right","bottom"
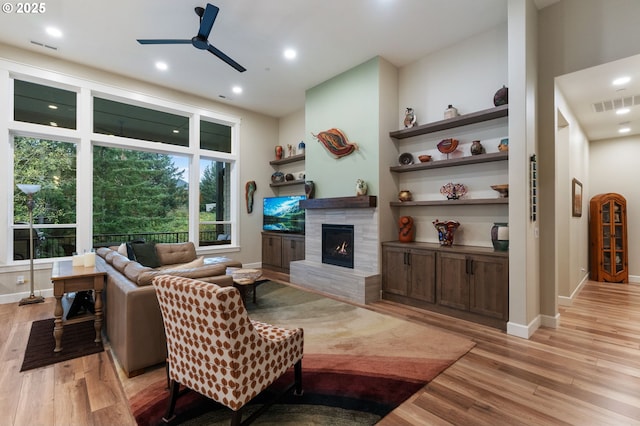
{"left": 589, "top": 193, "right": 629, "bottom": 283}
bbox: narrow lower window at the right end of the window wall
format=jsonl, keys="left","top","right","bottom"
{"left": 199, "top": 159, "right": 231, "bottom": 246}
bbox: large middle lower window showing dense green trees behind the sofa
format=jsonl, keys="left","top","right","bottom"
{"left": 93, "top": 146, "right": 189, "bottom": 246}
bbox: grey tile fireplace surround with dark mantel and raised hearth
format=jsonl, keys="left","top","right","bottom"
{"left": 290, "top": 196, "right": 381, "bottom": 304}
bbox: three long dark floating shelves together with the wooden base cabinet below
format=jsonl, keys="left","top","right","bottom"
{"left": 382, "top": 105, "right": 509, "bottom": 329}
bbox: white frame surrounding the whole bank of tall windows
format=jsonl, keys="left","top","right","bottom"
{"left": 0, "top": 63, "right": 241, "bottom": 265}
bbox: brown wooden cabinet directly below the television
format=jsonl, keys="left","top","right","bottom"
{"left": 262, "top": 232, "right": 304, "bottom": 274}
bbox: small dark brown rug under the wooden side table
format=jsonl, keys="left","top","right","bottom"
{"left": 20, "top": 318, "right": 104, "bottom": 371}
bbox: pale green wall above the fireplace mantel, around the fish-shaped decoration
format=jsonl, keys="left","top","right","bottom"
{"left": 305, "top": 57, "right": 380, "bottom": 198}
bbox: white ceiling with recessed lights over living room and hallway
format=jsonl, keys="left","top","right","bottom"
{"left": 0, "top": 0, "right": 640, "bottom": 139}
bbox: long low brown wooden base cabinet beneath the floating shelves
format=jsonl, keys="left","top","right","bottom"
{"left": 382, "top": 241, "right": 509, "bottom": 329}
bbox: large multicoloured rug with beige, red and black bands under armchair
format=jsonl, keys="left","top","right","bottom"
{"left": 129, "top": 281, "right": 474, "bottom": 425}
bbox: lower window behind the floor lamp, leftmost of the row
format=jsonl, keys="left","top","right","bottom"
{"left": 13, "top": 137, "right": 76, "bottom": 260}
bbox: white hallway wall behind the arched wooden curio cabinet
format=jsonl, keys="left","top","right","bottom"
{"left": 585, "top": 136, "right": 640, "bottom": 283}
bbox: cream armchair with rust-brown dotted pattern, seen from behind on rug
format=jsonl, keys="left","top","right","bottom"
{"left": 153, "top": 275, "right": 304, "bottom": 425}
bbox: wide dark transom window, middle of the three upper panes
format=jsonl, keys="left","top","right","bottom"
{"left": 93, "top": 98, "right": 189, "bottom": 146}
